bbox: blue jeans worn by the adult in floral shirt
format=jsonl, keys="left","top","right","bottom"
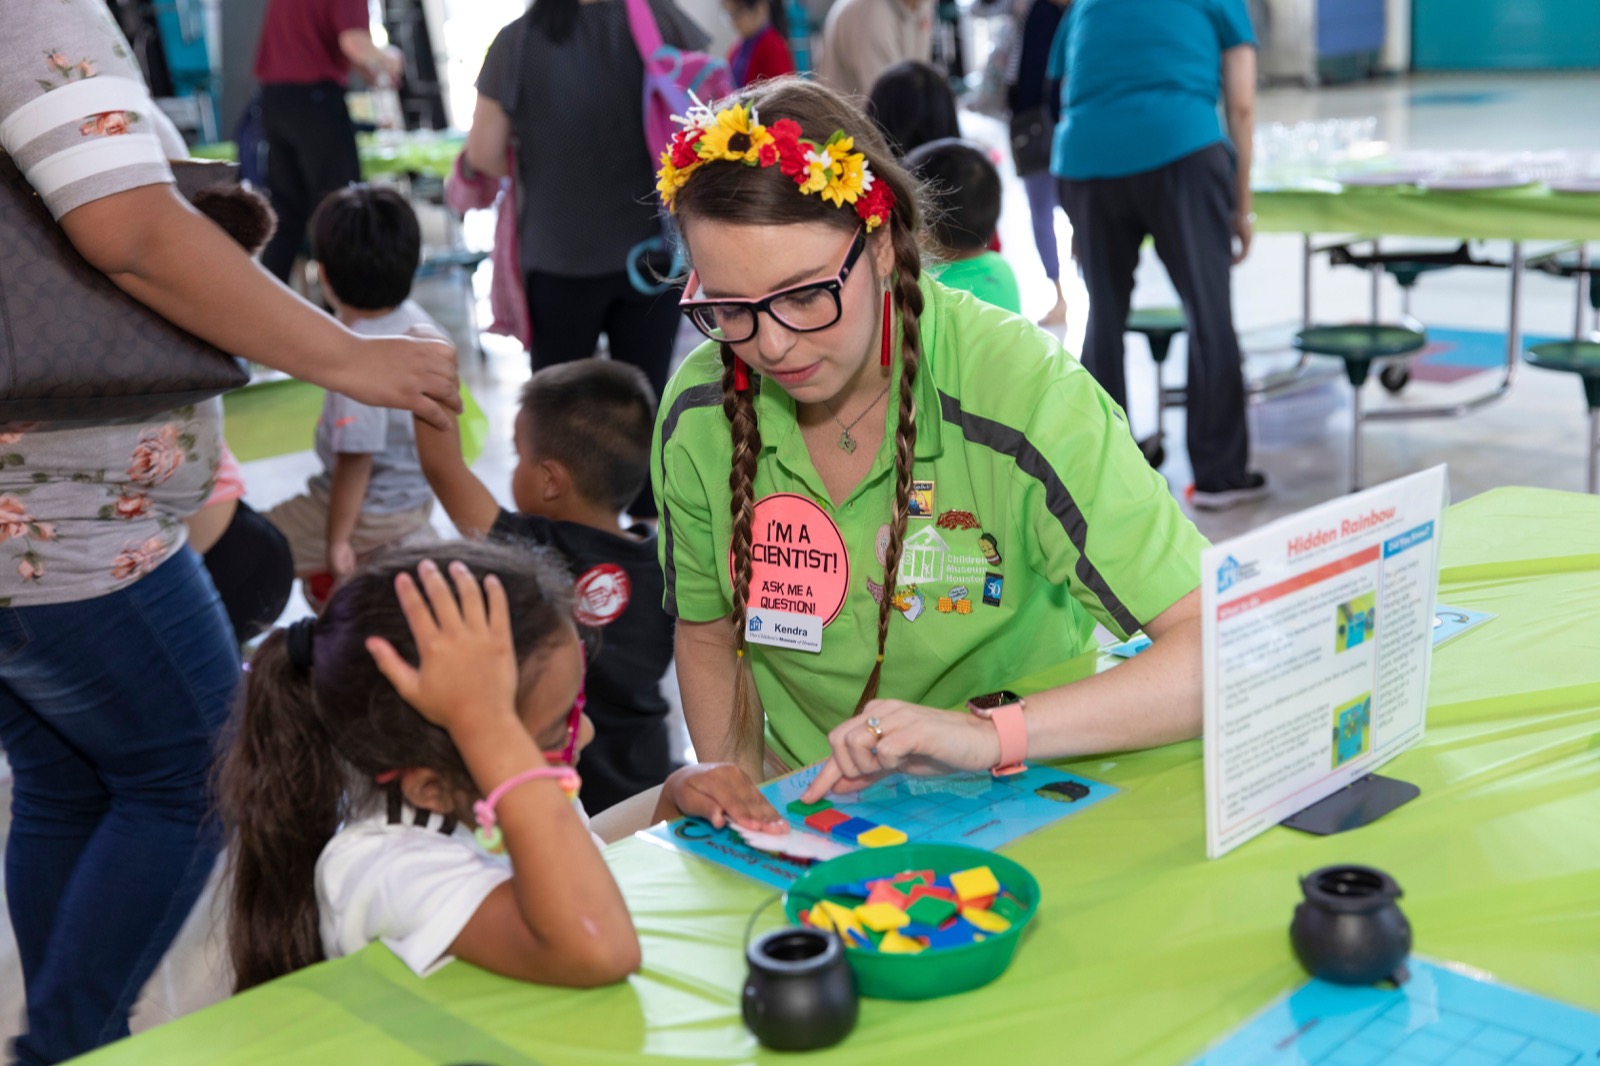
{"left": 0, "top": 547, "right": 240, "bottom": 1063}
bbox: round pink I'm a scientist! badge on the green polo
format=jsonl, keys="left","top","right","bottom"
{"left": 728, "top": 493, "right": 850, "bottom": 626}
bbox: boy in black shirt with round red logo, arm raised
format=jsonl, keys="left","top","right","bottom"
{"left": 416, "top": 359, "right": 677, "bottom": 815}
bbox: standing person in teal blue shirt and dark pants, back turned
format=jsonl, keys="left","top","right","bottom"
{"left": 1050, "top": 0, "right": 1267, "bottom": 509}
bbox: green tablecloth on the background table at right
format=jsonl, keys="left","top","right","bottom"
{"left": 1254, "top": 186, "right": 1600, "bottom": 240}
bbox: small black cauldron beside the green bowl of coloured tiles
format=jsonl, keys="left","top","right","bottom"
{"left": 744, "top": 925, "right": 861, "bottom": 1052}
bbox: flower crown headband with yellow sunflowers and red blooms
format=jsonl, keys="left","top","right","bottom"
{"left": 656, "top": 99, "right": 894, "bottom": 234}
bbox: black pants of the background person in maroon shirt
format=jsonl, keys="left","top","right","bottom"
{"left": 261, "top": 82, "right": 362, "bottom": 282}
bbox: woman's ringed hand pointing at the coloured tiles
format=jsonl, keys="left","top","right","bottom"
{"left": 800, "top": 699, "right": 1000, "bottom": 804}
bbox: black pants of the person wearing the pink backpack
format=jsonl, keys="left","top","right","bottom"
{"left": 526, "top": 271, "right": 680, "bottom": 519}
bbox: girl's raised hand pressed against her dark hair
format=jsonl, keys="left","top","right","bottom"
{"left": 366, "top": 560, "right": 517, "bottom": 735}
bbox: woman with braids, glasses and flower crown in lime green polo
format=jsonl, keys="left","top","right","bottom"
{"left": 651, "top": 80, "right": 1205, "bottom": 787}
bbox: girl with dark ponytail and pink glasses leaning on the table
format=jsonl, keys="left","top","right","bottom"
{"left": 218, "top": 543, "right": 778, "bottom": 991}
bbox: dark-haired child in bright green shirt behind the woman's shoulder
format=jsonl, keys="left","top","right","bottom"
{"left": 906, "top": 138, "right": 1022, "bottom": 315}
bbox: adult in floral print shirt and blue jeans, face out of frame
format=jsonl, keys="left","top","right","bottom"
{"left": 0, "top": 0, "right": 459, "bottom": 1063}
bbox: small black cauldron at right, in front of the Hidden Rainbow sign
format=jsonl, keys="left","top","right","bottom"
{"left": 1290, "top": 866, "right": 1411, "bottom": 984}
